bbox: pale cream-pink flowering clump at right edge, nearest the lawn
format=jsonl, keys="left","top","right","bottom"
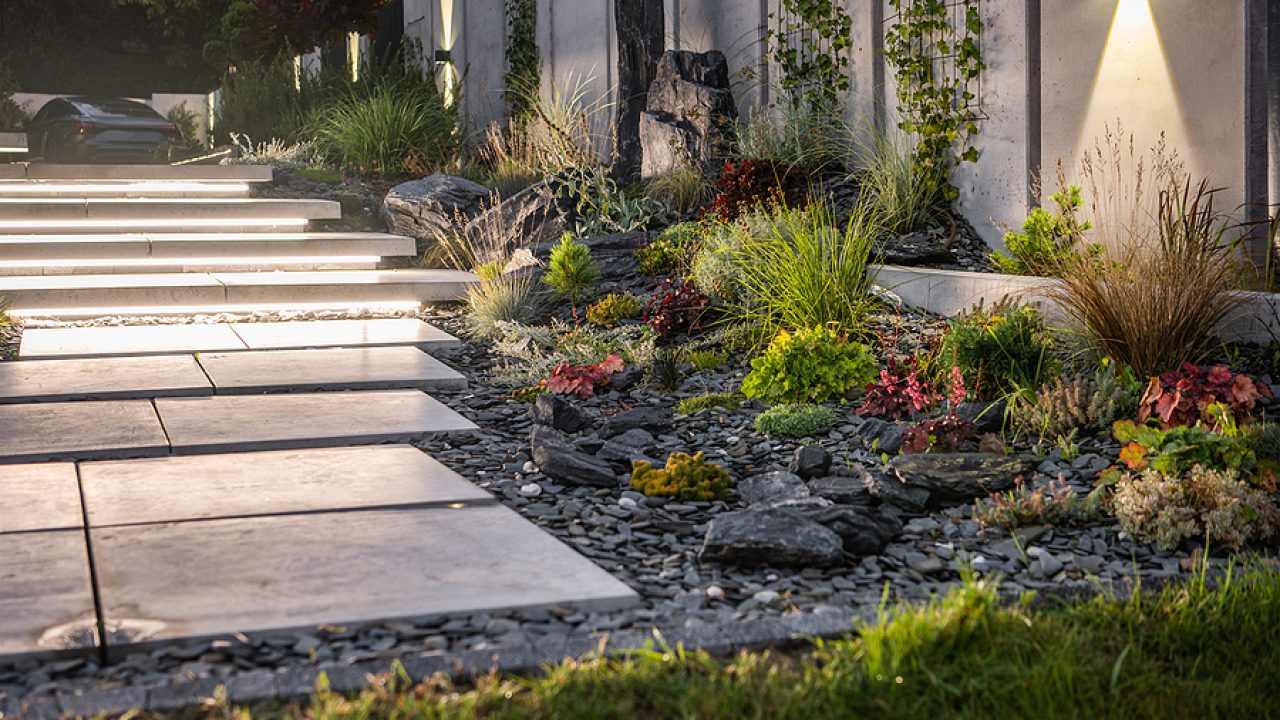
{"left": 1111, "top": 465, "right": 1280, "bottom": 550}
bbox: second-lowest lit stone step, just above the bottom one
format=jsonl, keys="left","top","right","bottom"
{"left": 0, "top": 232, "right": 417, "bottom": 260}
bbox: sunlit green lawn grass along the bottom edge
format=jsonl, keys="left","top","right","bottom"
{"left": 194, "top": 568, "right": 1280, "bottom": 720}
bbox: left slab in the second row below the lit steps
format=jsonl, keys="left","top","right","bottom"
{"left": 0, "top": 355, "right": 212, "bottom": 404}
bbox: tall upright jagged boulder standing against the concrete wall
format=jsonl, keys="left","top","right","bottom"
{"left": 640, "top": 50, "right": 737, "bottom": 178}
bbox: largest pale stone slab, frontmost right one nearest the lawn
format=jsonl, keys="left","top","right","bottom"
{"left": 91, "top": 505, "right": 636, "bottom": 642}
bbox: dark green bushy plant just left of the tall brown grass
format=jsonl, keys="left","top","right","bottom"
{"left": 937, "top": 295, "right": 1057, "bottom": 400}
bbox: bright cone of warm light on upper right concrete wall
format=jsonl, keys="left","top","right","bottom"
{"left": 1075, "top": 0, "right": 1189, "bottom": 165}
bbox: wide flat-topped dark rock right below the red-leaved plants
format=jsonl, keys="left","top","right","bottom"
{"left": 888, "top": 452, "right": 1030, "bottom": 507}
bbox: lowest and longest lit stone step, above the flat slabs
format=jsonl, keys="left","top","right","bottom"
{"left": 0, "top": 270, "right": 476, "bottom": 316}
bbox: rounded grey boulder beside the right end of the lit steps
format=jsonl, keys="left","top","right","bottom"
{"left": 383, "top": 173, "right": 489, "bottom": 252}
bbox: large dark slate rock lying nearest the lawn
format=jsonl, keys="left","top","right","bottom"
{"left": 699, "top": 507, "right": 844, "bottom": 568}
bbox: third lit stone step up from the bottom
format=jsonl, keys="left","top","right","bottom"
{"left": 0, "top": 197, "right": 342, "bottom": 226}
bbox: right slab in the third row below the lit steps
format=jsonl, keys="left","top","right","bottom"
{"left": 157, "top": 389, "right": 479, "bottom": 455}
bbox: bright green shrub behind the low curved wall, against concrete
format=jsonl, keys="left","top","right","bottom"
{"left": 991, "top": 184, "right": 1102, "bottom": 275}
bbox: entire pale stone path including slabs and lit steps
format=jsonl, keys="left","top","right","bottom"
{"left": 0, "top": 165, "right": 637, "bottom": 660}
